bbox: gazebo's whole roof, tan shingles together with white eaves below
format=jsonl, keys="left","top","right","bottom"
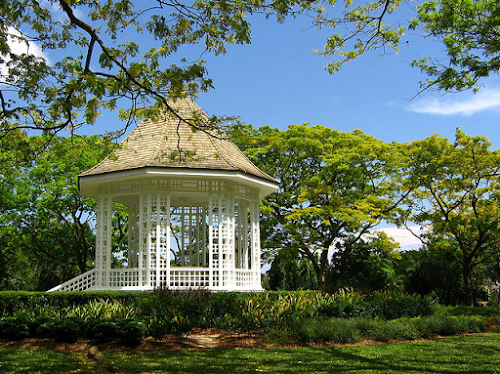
{"left": 79, "top": 97, "right": 278, "bottom": 196}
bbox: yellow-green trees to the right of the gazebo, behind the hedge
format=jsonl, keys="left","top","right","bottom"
{"left": 231, "top": 125, "right": 500, "bottom": 304}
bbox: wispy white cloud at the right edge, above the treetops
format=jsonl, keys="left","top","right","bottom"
{"left": 407, "top": 89, "right": 500, "bottom": 116}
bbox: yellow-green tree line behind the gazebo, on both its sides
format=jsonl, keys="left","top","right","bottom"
{"left": 0, "top": 124, "right": 500, "bottom": 304}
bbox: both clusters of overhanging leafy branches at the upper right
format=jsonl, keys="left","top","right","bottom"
{"left": 316, "top": 0, "right": 500, "bottom": 91}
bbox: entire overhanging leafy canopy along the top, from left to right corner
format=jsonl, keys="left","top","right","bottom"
{"left": 0, "top": 0, "right": 492, "bottom": 138}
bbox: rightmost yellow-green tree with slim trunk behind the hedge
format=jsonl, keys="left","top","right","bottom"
{"left": 401, "top": 129, "right": 500, "bottom": 304}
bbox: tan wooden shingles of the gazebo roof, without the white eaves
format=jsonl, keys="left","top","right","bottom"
{"left": 80, "top": 97, "right": 277, "bottom": 183}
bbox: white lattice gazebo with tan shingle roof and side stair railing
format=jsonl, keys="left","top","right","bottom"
{"left": 51, "top": 98, "right": 278, "bottom": 291}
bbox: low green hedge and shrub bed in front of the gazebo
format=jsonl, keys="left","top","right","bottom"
{"left": 0, "top": 289, "right": 492, "bottom": 345}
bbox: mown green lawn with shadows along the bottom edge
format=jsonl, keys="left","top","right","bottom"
{"left": 0, "top": 332, "right": 500, "bottom": 374}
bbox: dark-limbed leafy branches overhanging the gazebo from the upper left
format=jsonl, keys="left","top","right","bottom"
{"left": 0, "top": 0, "right": 376, "bottom": 137}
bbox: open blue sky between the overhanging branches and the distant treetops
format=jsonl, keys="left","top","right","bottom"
{"left": 188, "top": 5, "right": 500, "bottom": 149}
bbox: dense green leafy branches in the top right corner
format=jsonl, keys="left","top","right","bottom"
{"left": 411, "top": 0, "right": 500, "bottom": 91}
